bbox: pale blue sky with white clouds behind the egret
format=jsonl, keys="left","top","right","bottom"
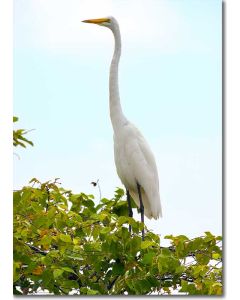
{"left": 14, "top": 0, "right": 222, "bottom": 237}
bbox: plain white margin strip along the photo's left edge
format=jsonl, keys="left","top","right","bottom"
{"left": 0, "top": 0, "right": 13, "bottom": 299}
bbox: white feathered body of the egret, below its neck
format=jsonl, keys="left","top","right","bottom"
{"left": 114, "top": 122, "right": 162, "bottom": 219}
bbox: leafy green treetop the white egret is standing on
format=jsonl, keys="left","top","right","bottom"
{"left": 13, "top": 118, "right": 222, "bottom": 295}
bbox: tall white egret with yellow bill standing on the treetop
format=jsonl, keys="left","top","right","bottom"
{"left": 82, "top": 17, "right": 162, "bottom": 239}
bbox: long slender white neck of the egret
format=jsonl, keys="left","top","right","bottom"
{"left": 109, "top": 27, "right": 126, "bottom": 132}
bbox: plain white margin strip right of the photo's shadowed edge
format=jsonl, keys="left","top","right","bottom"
{"left": 224, "top": 0, "right": 240, "bottom": 299}
